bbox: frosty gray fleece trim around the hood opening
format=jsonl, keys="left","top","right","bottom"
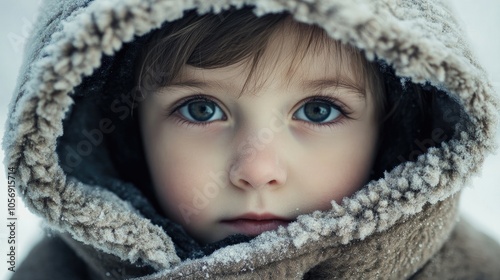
{"left": 3, "top": 0, "right": 498, "bottom": 269}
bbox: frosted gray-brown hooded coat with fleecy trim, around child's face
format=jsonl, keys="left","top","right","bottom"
{"left": 3, "top": 0, "right": 500, "bottom": 279}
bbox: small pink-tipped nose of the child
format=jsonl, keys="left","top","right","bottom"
{"left": 229, "top": 142, "right": 287, "bottom": 189}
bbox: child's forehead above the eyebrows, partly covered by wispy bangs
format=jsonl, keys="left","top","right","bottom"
{"left": 173, "top": 19, "right": 364, "bottom": 94}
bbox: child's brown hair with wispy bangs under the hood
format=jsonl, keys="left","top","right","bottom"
{"left": 136, "top": 8, "right": 385, "bottom": 119}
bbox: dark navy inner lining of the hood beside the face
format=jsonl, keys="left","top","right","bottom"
{"left": 57, "top": 10, "right": 469, "bottom": 260}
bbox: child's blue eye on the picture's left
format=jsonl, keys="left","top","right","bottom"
{"left": 179, "top": 99, "right": 224, "bottom": 122}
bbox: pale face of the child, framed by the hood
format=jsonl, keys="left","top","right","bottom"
{"left": 139, "top": 30, "right": 378, "bottom": 243}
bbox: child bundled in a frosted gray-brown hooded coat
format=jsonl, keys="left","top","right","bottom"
{"left": 5, "top": 1, "right": 500, "bottom": 279}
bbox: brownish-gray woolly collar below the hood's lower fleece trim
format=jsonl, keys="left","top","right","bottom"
{"left": 137, "top": 196, "right": 459, "bottom": 280}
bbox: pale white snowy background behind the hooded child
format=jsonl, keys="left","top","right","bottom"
{"left": 0, "top": 0, "right": 500, "bottom": 279}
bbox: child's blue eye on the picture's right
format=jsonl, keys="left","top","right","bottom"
{"left": 294, "top": 100, "right": 342, "bottom": 123}
